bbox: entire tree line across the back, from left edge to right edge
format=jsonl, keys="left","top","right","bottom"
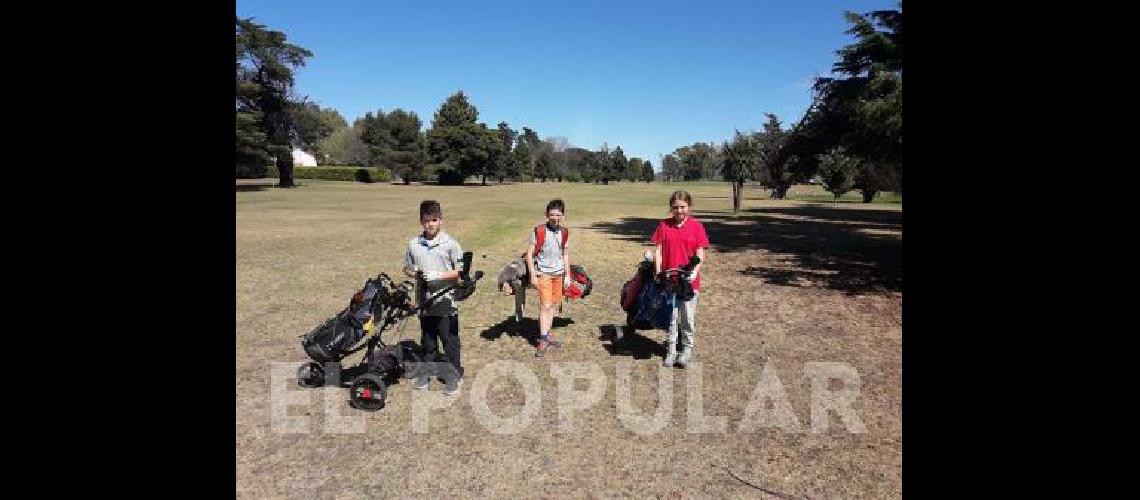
{"left": 236, "top": 2, "right": 903, "bottom": 197}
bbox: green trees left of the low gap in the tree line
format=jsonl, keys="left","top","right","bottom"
{"left": 236, "top": 18, "right": 653, "bottom": 187}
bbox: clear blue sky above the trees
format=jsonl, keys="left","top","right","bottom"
{"left": 237, "top": 0, "right": 898, "bottom": 169}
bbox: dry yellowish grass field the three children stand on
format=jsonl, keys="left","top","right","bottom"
{"left": 235, "top": 180, "right": 902, "bottom": 498}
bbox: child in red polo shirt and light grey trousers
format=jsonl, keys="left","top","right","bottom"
{"left": 652, "top": 190, "right": 709, "bottom": 368}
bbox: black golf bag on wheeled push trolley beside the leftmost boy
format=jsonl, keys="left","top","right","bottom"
{"left": 296, "top": 252, "right": 483, "bottom": 411}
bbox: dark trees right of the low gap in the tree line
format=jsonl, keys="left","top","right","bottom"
{"left": 659, "top": 2, "right": 903, "bottom": 212}
